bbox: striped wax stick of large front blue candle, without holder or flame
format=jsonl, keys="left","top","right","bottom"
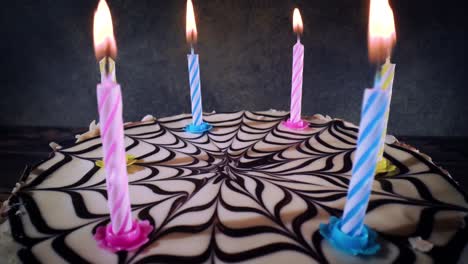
{"left": 341, "top": 87, "right": 390, "bottom": 236}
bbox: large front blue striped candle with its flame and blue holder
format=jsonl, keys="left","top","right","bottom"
{"left": 320, "top": 0, "right": 395, "bottom": 255}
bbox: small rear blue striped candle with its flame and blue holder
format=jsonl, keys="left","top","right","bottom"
{"left": 185, "top": 0, "right": 212, "bottom": 133}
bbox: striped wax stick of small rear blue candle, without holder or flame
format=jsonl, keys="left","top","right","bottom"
{"left": 187, "top": 48, "right": 203, "bottom": 126}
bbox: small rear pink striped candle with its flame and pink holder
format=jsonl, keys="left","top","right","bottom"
{"left": 284, "top": 8, "right": 309, "bottom": 129}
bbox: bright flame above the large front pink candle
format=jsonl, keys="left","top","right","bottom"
{"left": 93, "top": 0, "right": 117, "bottom": 60}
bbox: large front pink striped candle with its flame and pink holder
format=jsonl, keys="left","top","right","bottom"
{"left": 94, "top": 0, "right": 153, "bottom": 251}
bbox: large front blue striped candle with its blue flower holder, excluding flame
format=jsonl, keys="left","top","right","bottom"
{"left": 320, "top": 87, "right": 390, "bottom": 255}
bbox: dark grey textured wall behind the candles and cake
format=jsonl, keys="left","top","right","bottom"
{"left": 0, "top": 0, "right": 468, "bottom": 136}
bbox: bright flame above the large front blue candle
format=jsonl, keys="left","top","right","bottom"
{"left": 368, "top": 0, "right": 396, "bottom": 63}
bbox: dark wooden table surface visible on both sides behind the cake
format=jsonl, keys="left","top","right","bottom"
{"left": 0, "top": 127, "right": 468, "bottom": 194}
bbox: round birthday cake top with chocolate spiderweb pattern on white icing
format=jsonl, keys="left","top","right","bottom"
{"left": 2, "top": 110, "right": 468, "bottom": 263}
